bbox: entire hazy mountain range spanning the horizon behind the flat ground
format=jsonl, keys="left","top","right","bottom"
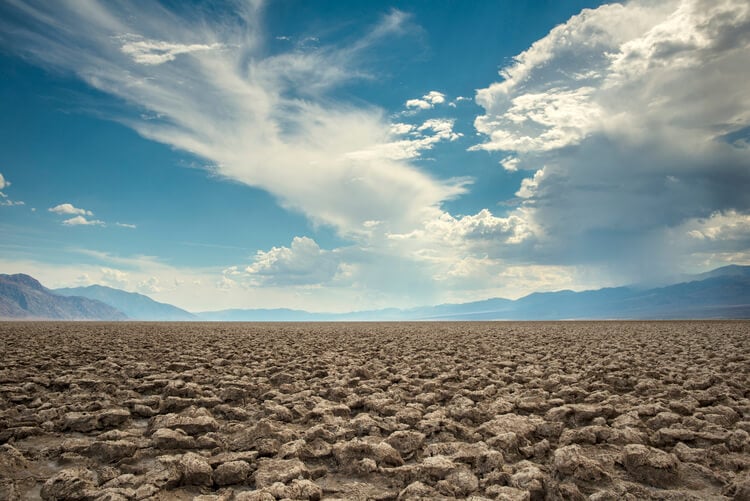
{"left": 0, "top": 265, "right": 750, "bottom": 322}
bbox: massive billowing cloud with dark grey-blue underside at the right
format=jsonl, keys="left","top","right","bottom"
{"left": 473, "top": 0, "right": 750, "bottom": 280}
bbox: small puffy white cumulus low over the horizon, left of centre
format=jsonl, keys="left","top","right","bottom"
{"left": 245, "top": 237, "right": 339, "bottom": 286}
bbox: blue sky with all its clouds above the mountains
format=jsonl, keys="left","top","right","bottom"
{"left": 0, "top": 0, "right": 750, "bottom": 312}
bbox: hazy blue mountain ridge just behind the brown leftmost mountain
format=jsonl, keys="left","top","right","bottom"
{"left": 54, "top": 285, "right": 198, "bottom": 321}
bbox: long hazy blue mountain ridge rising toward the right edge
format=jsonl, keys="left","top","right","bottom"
{"left": 197, "top": 265, "right": 750, "bottom": 321}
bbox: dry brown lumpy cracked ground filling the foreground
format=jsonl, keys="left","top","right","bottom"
{"left": 0, "top": 322, "right": 750, "bottom": 501}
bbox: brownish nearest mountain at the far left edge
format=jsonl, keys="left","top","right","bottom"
{"left": 0, "top": 274, "right": 126, "bottom": 320}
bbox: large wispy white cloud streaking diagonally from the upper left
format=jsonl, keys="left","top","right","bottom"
{"left": 2, "top": 1, "right": 465, "bottom": 238}
